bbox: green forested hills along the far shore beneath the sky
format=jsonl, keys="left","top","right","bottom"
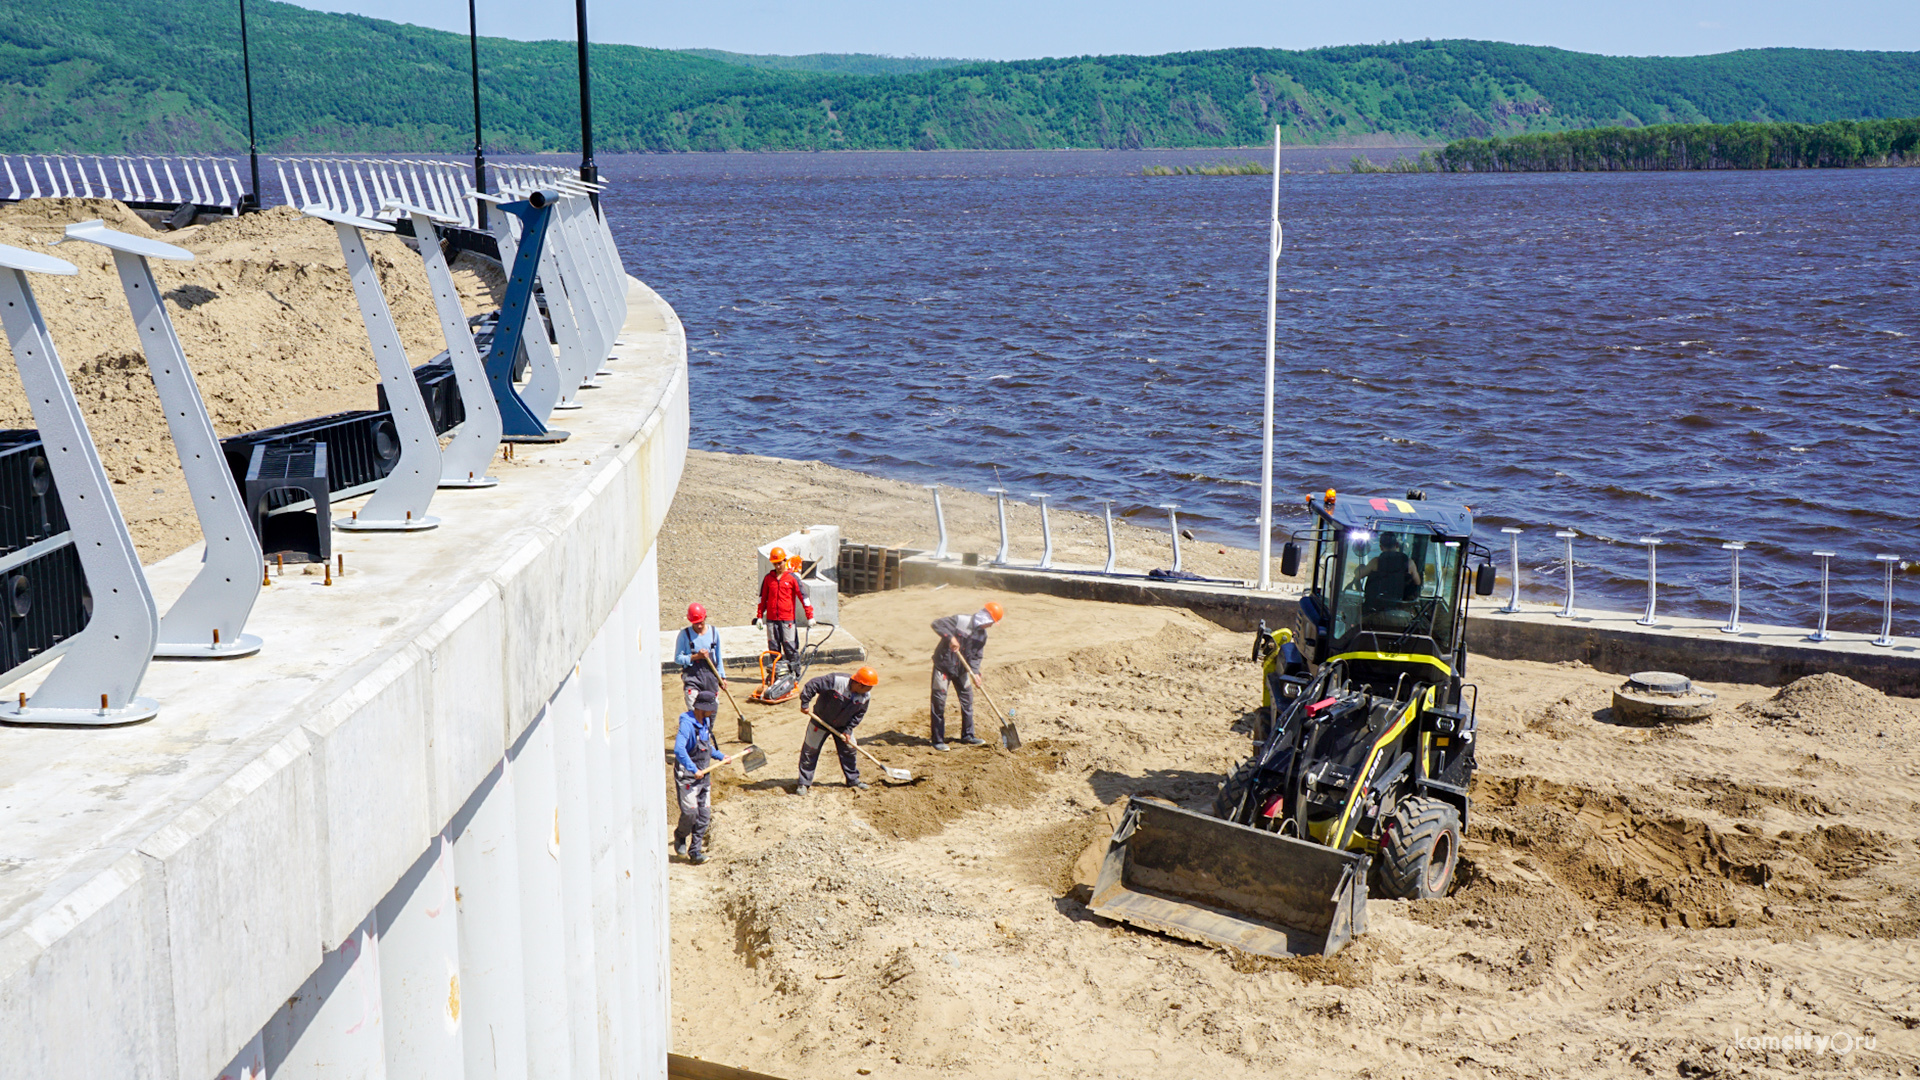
{"left": 0, "top": 0, "right": 1920, "bottom": 152}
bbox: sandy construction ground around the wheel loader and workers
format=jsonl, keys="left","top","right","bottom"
{"left": 662, "top": 455, "right": 1920, "bottom": 1078}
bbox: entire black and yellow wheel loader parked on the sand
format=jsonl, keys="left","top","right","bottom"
{"left": 1089, "top": 490, "right": 1494, "bottom": 957}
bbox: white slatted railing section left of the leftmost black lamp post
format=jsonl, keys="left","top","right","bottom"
{"left": 0, "top": 154, "right": 248, "bottom": 213}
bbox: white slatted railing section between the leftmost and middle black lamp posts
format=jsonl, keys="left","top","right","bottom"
{"left": 271, "top": 158, "right": 478, "bottom": 229}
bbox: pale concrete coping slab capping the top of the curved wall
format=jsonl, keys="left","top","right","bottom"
{"left": 0, "top": 272, "right": 689, "bottom": 1076}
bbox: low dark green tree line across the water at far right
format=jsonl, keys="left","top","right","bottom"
{"left": 1434, "top": 117, "right": 1920, "bottom": 173}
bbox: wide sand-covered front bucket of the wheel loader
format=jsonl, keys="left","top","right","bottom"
{"left": 1087, "top": 799, "right": 1369, "bottom": 959}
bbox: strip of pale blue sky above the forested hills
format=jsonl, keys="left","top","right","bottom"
{"left": 288, "top": 0, "right": 1920, "bottom": 60}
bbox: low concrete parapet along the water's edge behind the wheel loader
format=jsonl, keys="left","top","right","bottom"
{"left": 900, "top": 555, "right": 1920, "bottom": 698}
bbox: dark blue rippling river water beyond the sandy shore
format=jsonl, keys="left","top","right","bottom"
{"left": 601, "top": 152, "right": 1920, "bottom": 634}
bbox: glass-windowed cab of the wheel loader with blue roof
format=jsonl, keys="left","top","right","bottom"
{"left": 1300, "top": 492, "right": 1492, "bottom": 698}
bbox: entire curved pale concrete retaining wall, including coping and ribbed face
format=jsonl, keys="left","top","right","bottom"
{"left": 0, "top": 272, "right": 687, "bottom": 1080}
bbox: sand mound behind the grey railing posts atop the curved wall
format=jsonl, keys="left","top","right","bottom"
{"left": 0, "top": 198, "right": 497, "bottom": 561}
